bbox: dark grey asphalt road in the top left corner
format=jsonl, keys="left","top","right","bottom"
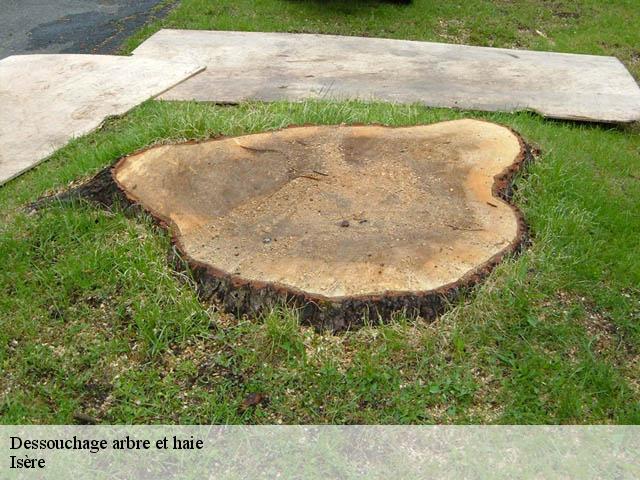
{"left": 0, "top": 0, "right": 168, "bottom": 58}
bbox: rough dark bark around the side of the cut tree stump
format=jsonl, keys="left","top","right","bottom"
{"left": 31, "top": 127, "right": 533, "bottom": 332}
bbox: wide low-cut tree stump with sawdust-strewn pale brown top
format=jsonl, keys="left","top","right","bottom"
{"left": 112, "top": 120, "right": 526, "bottom": 328}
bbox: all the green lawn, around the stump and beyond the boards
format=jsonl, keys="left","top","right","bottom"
{"left": 0, "top": 0, "right": 640, "bottom": 423}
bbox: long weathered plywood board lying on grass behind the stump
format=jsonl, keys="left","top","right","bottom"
{"left": 134, "top": 30, "right": 640, "bottom": 123}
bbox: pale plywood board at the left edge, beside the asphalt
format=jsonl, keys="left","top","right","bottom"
{"left": 0, "top": 54, "right": 200, "bottom": 185}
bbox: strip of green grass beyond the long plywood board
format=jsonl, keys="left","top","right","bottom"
{"left": 123, "top": 0, "right": 640, "bottom": 78}
